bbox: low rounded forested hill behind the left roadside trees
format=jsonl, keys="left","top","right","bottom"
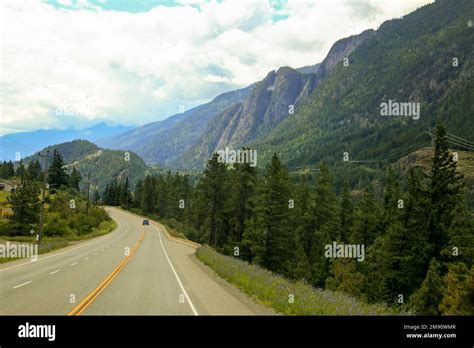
{"left": 25, "top": 140, "right": 148, "bottom": 192}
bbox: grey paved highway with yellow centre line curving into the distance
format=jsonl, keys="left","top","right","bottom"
{"left": 0, "top": 207, "right": 273, "bottom": 315}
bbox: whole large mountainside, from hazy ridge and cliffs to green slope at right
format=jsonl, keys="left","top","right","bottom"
{"left": 2, "top": 0, "right": 474, "bottom": 174}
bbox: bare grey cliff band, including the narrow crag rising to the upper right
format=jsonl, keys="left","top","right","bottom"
{"left": 170, "top": 30, "right": 374, "bottom": 168}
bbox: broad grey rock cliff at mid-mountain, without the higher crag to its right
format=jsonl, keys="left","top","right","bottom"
{"left": 172, "top": 67, "right": 316, "bottom": 167}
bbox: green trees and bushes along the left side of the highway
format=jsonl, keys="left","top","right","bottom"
{"left": 0, "top": 151, "right": 116, "bottom": 263}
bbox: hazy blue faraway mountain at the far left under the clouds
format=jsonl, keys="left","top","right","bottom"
{"left": 0, "top": 122, "right": 133, "bottom": 160}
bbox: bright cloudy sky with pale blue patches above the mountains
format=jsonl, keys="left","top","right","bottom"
{"left": 0, "top": 0, "right": 431, "bottom": 134}
